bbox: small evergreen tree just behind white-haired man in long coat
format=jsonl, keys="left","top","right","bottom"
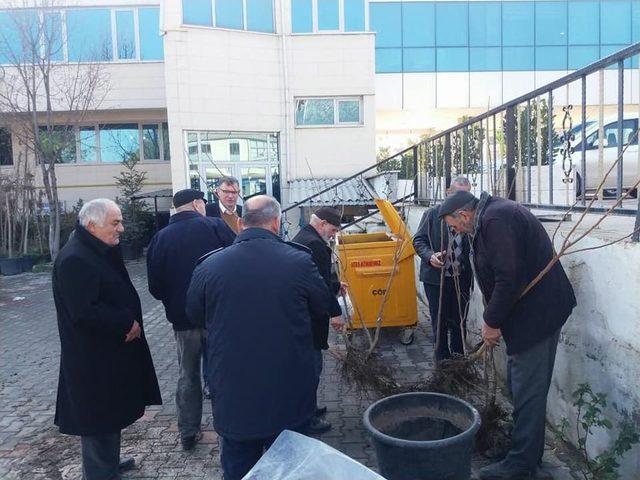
{"left": 115, "top": 152, "right": 148, "bottom": 260}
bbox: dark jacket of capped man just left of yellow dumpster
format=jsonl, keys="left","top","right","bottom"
{"left": 293, "top": 225, "right": 342, "bottom": 350}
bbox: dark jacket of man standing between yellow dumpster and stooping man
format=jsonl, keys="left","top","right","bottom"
{"left": 413, "top": 205, "right": 473, "bottom": 286}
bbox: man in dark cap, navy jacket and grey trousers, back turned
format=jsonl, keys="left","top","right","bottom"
{"left": 147, "top": 189, "right": 235, "bottom": 450}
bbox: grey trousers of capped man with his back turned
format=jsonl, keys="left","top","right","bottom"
{"left": 175, "top": 328, "right": 207, "bottom": 439}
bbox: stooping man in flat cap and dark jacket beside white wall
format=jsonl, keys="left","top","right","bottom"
{"left": 440, "top": 192, "right": 576, "bottom": 480}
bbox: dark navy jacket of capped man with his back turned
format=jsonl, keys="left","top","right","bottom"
{"left": 147, "top": 211, "right": 235, "bottom": 331}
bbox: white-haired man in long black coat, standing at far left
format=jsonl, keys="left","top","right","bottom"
{"left": 52, "top": 199, "right": 162, "bottom": 480}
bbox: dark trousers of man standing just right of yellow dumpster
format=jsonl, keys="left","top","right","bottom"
{"left": 423, "top": 277, "right": 471, "bottom": 361}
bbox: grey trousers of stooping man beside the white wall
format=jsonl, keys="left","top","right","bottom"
{"left": 506, "top": 329, "right": 560, "bottom": 470}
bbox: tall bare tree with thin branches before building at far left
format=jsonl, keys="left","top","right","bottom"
{"left": 0, "top": 0, "right": 110, "bottom": 258}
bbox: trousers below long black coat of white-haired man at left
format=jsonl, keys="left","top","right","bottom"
{"left": 80, "top": 432, "right": 120, "bottom": 480}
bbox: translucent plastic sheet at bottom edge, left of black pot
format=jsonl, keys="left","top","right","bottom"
{"left": 243, "top": 430, "right": 384, "bottom": 480}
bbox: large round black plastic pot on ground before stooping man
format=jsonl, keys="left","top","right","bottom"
{"left": 364, "top": 392, "right": 480, "bottom": 480}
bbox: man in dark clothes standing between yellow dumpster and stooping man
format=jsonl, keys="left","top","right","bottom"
{"left": 413, "top": 177, "right": 473, "bottom": 362}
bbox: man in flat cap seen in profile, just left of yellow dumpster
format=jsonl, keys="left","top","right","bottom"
{"left": 293, "top": 207, "right": 346, "bottom": 433}
